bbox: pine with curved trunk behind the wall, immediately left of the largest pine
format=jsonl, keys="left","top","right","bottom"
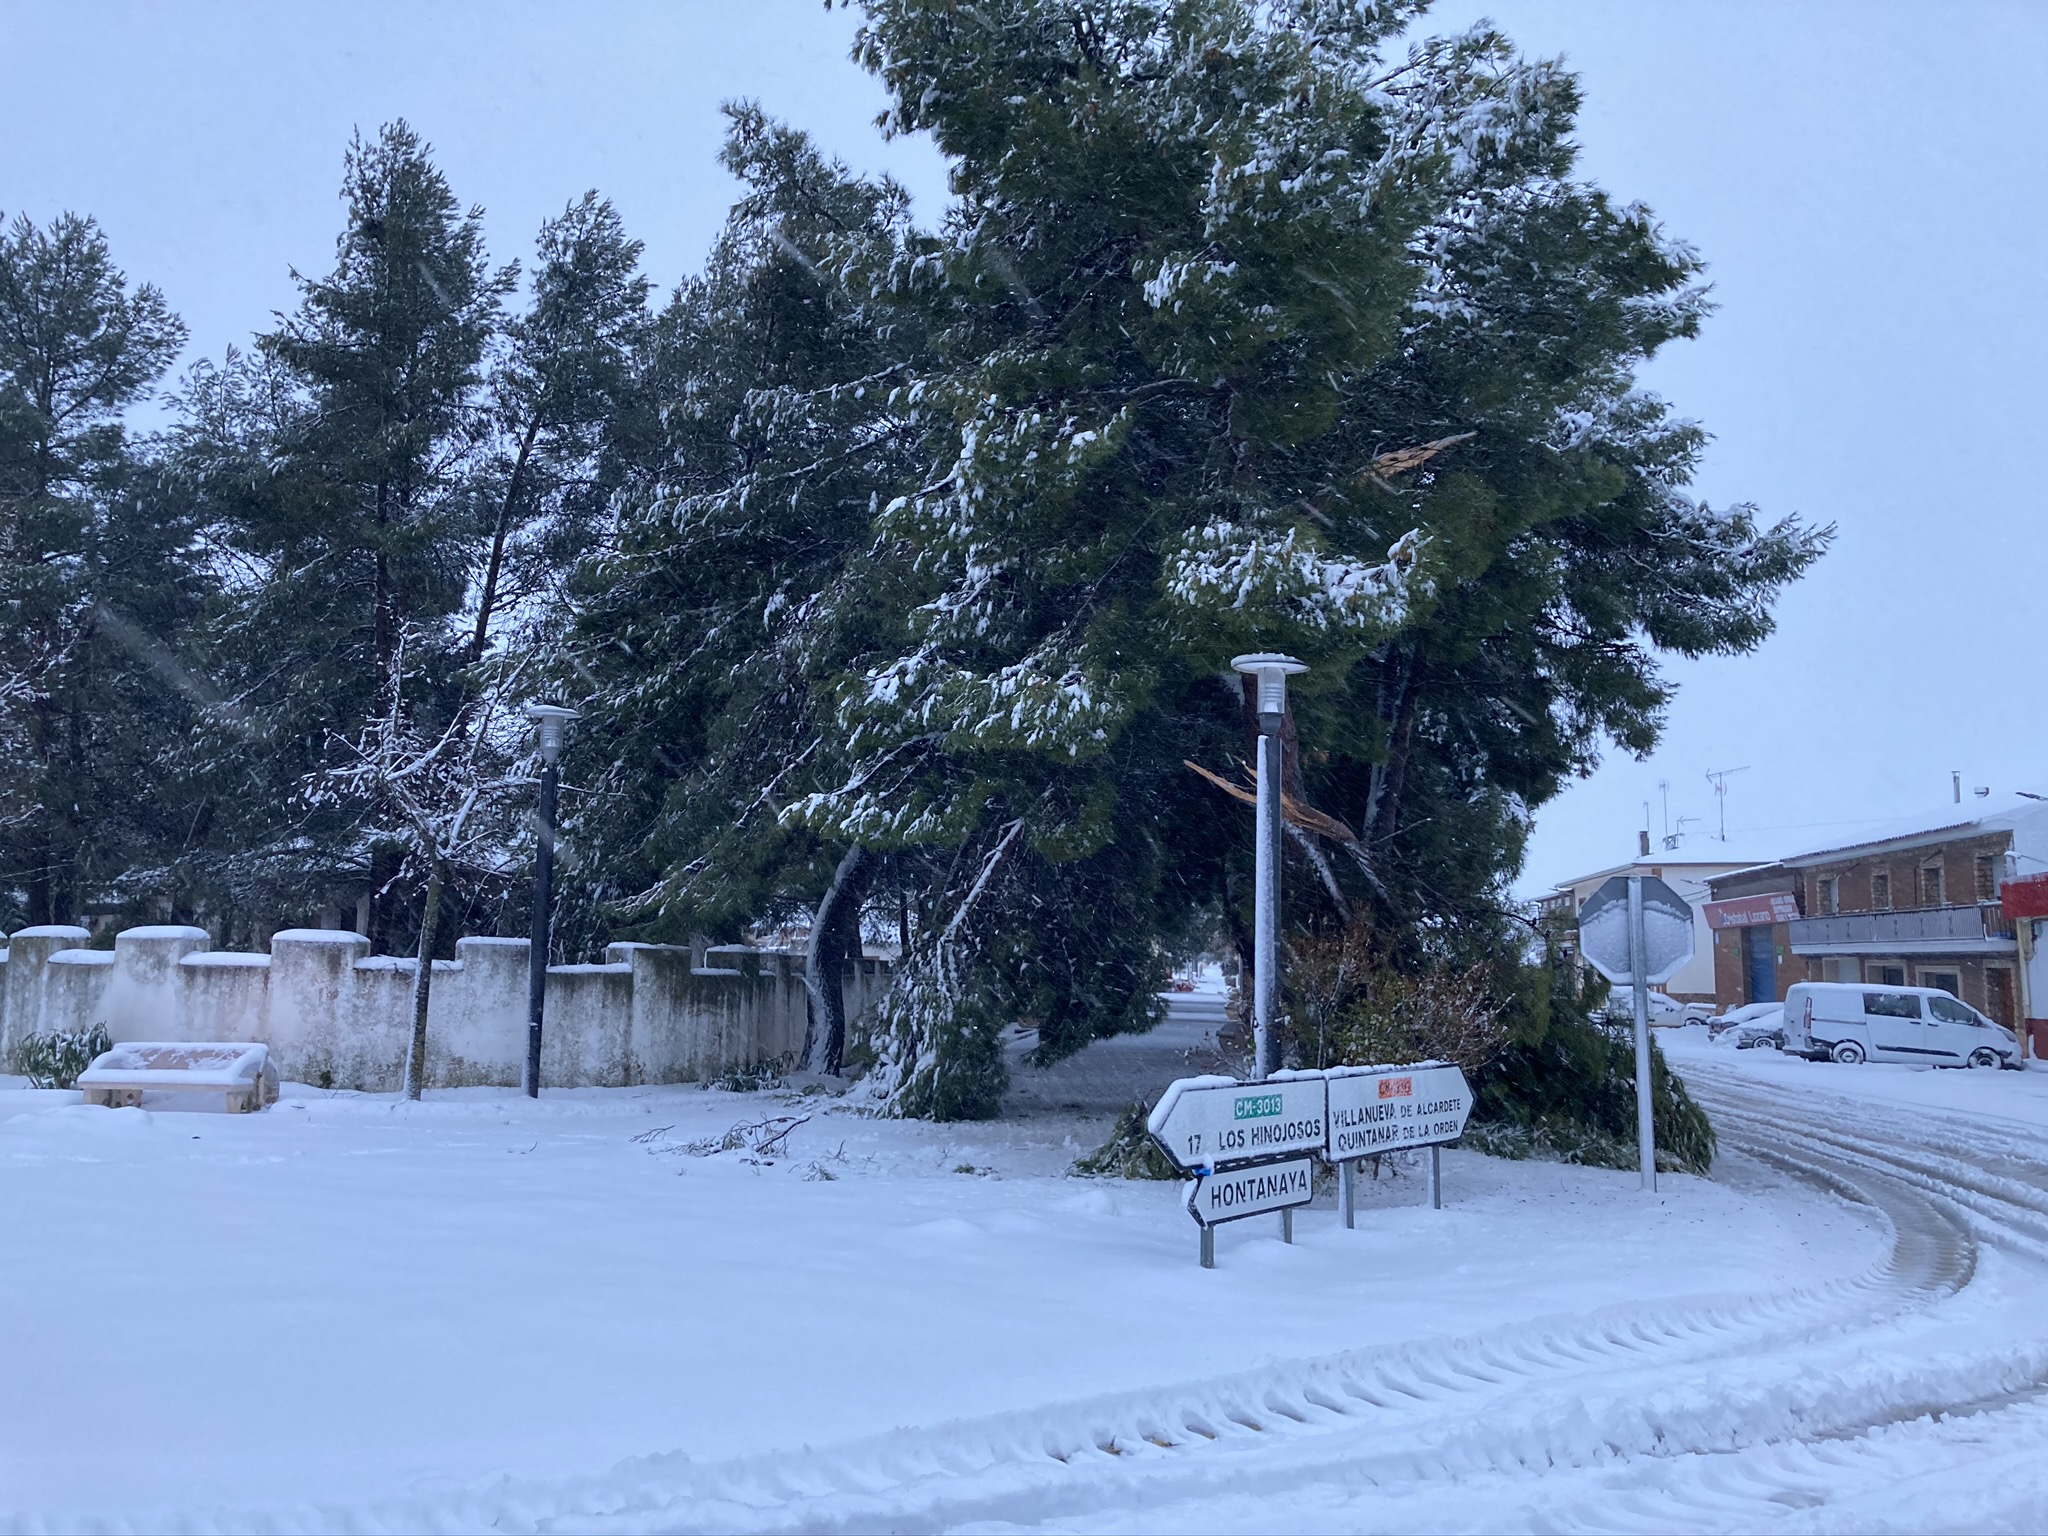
{"left": 571, "top": 106, "right": 918, "bottom": 1071}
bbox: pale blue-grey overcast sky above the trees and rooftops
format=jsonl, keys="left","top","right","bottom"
{"left": 0, "top": 0, "right": 2048, "bottom": 891}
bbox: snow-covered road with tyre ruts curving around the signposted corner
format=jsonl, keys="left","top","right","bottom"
{"left": 448, "top": 1057, "right": 2048, "bottom": 1532}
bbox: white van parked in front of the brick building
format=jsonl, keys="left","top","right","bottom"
{"left": 1786, "top": 981, "right": 2019, "bottom": 1067}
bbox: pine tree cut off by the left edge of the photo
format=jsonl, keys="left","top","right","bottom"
{"left": 0, "top": 213, "right": 203, "bottom": 928}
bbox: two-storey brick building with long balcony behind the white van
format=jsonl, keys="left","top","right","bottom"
{"left": 1706, "top": 801, "right": 2048, "bottom": 1028}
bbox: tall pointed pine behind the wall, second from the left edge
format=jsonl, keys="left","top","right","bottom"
{"left": 182, "top": 123, "right": 516, "bottom": 942}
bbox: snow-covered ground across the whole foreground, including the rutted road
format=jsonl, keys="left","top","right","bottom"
{"left": 0, "top": 999, "right": 2048, "bottom": 1530}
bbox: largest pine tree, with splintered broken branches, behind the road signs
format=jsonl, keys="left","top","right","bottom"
{"left": 770, "top": 0, "right": 1825, "bottom": 1114}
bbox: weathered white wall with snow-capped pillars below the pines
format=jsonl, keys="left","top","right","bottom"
{"left": 0, "top": 926, "right": 891, "bottom": 1092}
